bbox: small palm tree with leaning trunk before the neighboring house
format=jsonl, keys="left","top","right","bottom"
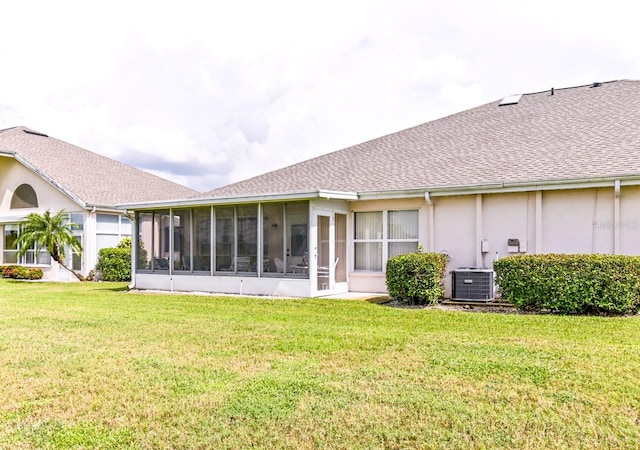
{"left": 16, "top": 210, "right": 84, "bottom": 281}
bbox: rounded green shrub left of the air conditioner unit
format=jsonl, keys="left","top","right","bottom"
{"left": 386, "top": 252, "right": 447, "bottom": 305}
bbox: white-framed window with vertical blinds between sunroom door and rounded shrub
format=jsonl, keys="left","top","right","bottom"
{"left": 354, "top": 211, "right": 419, "bottom": 272}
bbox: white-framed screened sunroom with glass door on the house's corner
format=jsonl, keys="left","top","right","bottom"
{"left": 133, "top": 199, "right": 348, "bottom": 297}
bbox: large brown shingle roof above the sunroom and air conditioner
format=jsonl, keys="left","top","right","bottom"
{"left": 200, "top": 80, "right": 640, "bottom": 198}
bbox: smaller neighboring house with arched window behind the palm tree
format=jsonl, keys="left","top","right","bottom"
{"left": 0, "top": 127, "right": 197, "bottom": 280}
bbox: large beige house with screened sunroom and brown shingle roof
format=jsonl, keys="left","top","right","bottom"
{"left": 126, "top": 80, "right": 640, "bottom": 297}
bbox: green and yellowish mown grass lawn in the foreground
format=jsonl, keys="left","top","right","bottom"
{"left": 0, "top": 280, "right": 640, "bottom": 449}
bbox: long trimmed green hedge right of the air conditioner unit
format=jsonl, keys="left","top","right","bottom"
{"left": 493, "top": 254, "right": 640, "bottom": 314}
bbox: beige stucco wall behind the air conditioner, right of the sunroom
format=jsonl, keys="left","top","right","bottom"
{"left": 349, "top": 183, "right": 640, "bottom": 297}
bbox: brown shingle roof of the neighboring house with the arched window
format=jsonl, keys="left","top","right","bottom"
{"left": 0, "top": 126, "right": 198, "bottom": 206}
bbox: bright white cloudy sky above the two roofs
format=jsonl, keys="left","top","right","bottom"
{"left": 0, "top": 0, "right": 640, "bottom": 192}
